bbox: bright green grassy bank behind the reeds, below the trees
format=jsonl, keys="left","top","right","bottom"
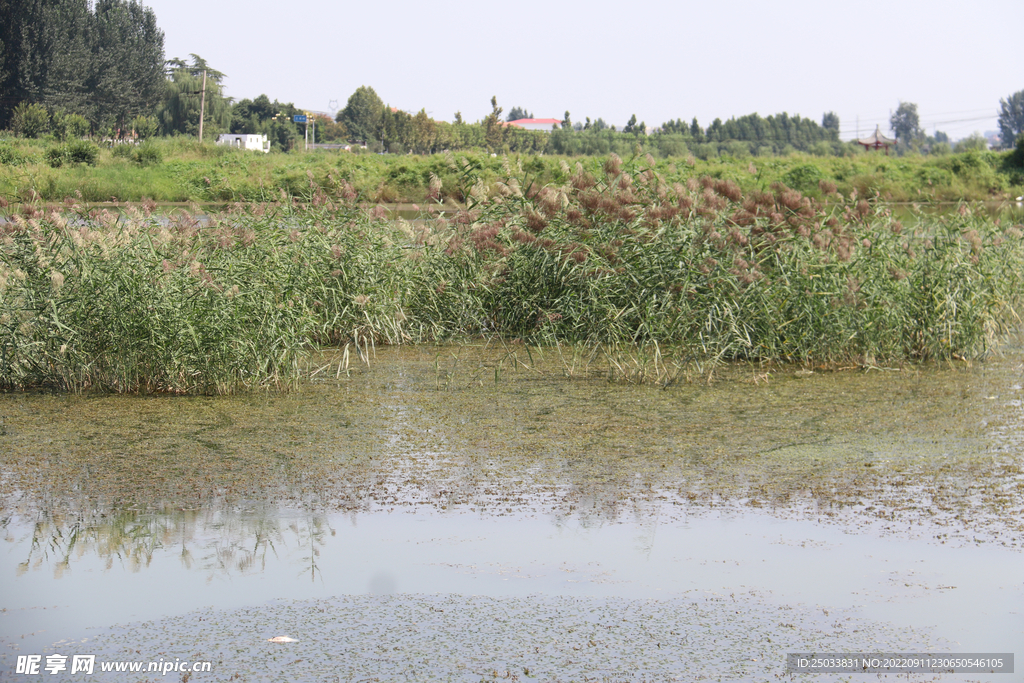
{"left": 6, "top": 138, "right": 1024, "bottom": 203}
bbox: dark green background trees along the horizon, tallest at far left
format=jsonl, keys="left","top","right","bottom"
{"left": 0, "top": 0, "right": 1024, "bottom": 159}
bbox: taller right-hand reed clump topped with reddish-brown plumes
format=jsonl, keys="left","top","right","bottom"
{"left": 457, "top": 160, "right": 1022, "bottom": 365}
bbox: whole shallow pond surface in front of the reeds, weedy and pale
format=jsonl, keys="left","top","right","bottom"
{"left": 0, "top": 343, "right": 1024, "bottom": 681}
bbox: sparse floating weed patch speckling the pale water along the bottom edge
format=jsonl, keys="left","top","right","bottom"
{"left": 41, "top": 592, "right": 943, "bottom": 683}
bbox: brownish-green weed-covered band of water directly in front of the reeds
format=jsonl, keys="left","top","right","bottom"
{"left": 6, "top": 345, "right": 1024, "bottom": 579}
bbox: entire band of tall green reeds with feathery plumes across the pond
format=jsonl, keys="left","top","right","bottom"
{"left": 0, "top": 157, "right": 1024, "bottom": 393}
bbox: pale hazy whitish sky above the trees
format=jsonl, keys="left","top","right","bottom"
{"left": 143, "top": 0, "right": 1024, "bottom": 139}
